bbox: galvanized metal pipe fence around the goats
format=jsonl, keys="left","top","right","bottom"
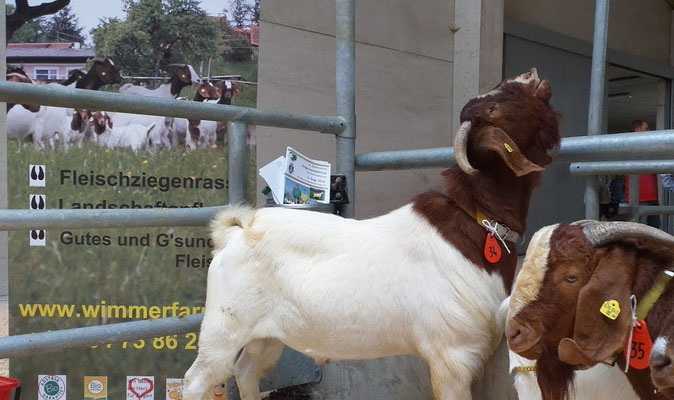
{"left": 0, "top": 0, "right": 674, "bottom": 358}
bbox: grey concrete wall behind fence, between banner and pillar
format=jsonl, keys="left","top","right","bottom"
{"left": 257, "top": 0, "right": 454, "bottom": 218}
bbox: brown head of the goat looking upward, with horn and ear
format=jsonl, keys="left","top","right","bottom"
{"left": 454, "top": 68, "right": 561, "bottom": 177}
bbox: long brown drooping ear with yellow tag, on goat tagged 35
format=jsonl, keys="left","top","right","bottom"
{"left": 557, "top": 246, "right": 636, "bottom": 367}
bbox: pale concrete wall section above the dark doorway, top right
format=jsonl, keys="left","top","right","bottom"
{"left": 505, "top": 0, "right": 672, "bottom": 64}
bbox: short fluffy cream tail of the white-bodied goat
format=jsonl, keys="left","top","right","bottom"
{"left": 210, "top": 205, "right": 263, "bottom": 255}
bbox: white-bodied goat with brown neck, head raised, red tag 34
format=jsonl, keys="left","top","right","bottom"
{"left": 183, "top": 69, "right": 560, "bottom": 400}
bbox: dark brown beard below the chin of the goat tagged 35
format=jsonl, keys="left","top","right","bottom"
{"left": 536, "top": 348, "right": 576, "bottom": 400}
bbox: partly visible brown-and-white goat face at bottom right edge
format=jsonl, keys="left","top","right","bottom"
{"left": 649, "top": 308, "right": 674, "bottom": 399}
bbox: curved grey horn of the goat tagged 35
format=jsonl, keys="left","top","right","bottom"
{"left": 572, "top": 220, "right": 674, "bottom": 247}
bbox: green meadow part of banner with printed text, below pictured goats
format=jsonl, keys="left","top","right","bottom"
{"left": 8, "top": 140, "right": 249, "bottom": 400}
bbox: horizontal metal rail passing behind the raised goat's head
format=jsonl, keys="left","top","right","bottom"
{"left": 356, "top": 130, "right": 674, "bottom": 171}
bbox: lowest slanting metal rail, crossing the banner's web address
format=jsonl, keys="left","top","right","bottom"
{"left": 0, "top": 314, "right": 203, "bottom": 358}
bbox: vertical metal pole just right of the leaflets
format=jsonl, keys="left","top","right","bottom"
{"left": 335, "top": 0, "right": 356, "bottom": 218}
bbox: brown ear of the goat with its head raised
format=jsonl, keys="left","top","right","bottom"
{"left": 473, "top": 126, "right": 543, "bottom": 176}
